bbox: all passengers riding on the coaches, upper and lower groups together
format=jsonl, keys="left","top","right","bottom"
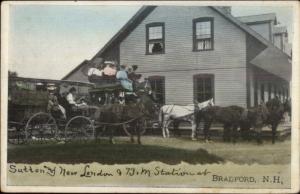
{"left": 47, "top": 58, "right": 141, "bottom": 119}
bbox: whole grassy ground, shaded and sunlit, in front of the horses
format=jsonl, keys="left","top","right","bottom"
{"left": 8, "top": 136, "right": 291, "bottom": 164}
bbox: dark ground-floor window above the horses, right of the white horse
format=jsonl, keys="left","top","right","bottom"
{"left": 194, "top": 74, "right": 214, "bottom": 102}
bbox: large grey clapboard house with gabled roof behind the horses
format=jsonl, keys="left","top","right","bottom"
{"left": 63, "top": 6, "right": 291, "bottom": 107}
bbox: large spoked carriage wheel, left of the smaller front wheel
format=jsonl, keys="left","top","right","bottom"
{"left": 25, "top": 112, "right": 58, "bottom": 141}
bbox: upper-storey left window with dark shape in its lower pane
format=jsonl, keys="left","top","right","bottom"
{"left": 146, "top": 23, "right": 165, "bottom": 54}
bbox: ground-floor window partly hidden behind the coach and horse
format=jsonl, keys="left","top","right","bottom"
{"left": 148, "top": 76, "right": 165, "bottom": 104}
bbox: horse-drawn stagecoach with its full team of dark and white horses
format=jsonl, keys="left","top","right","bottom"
{"left": 8, "top": 74, "right": 290, "bottom": 143}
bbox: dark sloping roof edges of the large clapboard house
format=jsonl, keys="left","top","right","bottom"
{"left": 63, "top": 6, "right": 290, "bottom": 79}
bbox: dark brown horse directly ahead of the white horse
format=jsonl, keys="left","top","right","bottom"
{"left": 197, "top": 106, "right": 244, "bottom": 142}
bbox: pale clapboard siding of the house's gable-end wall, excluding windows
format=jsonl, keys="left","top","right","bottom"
{"left": 120, "top": 6, "right": 247, "bottom": 107}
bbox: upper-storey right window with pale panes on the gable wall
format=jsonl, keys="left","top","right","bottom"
{"left": 193, "top": 18, "right": 214, "bottom": 51}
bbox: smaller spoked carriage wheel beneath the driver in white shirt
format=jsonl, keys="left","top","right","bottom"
{"left": 65, "top": 116, "right": 95, "bottom": 141}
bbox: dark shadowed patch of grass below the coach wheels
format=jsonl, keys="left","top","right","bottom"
{"left": 8, "top": 141, "right": 223, "bottom": 164}
